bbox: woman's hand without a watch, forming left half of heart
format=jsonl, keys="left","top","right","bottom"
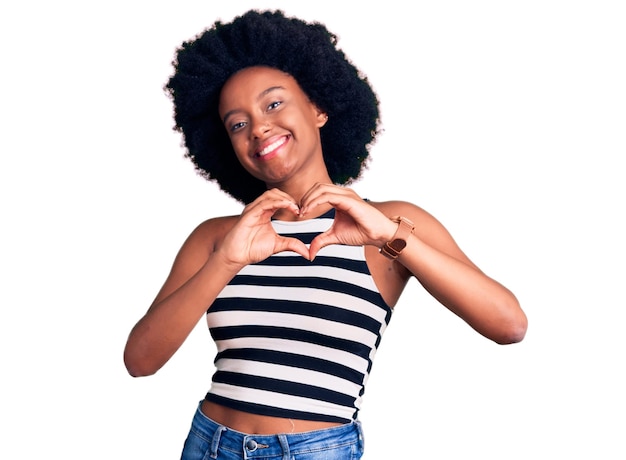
{"left": 218, "top": 189, "right": 309, "bottom": 267}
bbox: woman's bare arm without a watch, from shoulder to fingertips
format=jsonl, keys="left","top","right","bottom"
{"left": 124, "top": 190, "right": 309, "bottom": 376}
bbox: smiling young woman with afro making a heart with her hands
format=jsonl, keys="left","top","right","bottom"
{"left": 124, "top": 11, "right": 527, "bottom": 460}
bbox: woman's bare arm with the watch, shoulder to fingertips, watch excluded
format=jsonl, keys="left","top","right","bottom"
{"left": 303, "top": 185, "right": 527, "bottom": 344}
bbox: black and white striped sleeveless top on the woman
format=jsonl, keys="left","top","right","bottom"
{"left": 206, "top": 209, "right": 392, "bottom": 423}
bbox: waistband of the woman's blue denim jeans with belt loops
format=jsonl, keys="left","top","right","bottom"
{"left": 193, "top": 405, "right": 363, "bottom": 459}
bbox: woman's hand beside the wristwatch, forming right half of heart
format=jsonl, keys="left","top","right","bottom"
{"left": 300, "top": 184, "right": 397, "bottom": 260}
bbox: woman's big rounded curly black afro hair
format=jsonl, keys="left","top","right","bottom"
{"left": 164, "top": 10, "right": 380, "bottom": 204}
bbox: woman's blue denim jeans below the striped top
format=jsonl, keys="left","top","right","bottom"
{"left": 181, "top": 405, "right": 363, "bottom": 460}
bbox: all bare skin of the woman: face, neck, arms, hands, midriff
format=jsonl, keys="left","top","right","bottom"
{"left": 124, "top": 67, "right": 527, "bottom": 434}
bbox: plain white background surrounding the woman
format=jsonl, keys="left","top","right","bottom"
{"left": 0, "top": 0, "right": 626, "bottom": 460}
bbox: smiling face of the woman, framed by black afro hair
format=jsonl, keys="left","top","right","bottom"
{"left": 219, "top": 67, "right": 328, "bottom": 186}
